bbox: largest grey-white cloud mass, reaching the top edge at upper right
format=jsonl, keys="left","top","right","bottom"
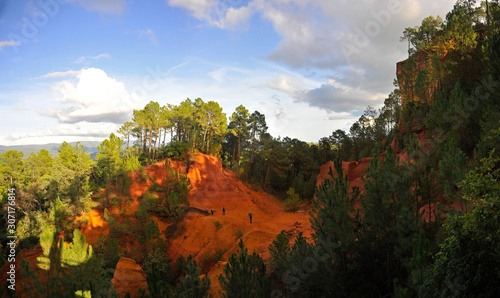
{"left": 171, "top": 0, "right": 456, "bottom": 111}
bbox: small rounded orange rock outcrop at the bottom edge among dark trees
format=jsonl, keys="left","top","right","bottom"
{"left": 111, "top": 257, "right": 148, "bottom": 297}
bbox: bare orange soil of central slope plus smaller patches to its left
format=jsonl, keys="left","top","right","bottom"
{"left": 75, "top": 153, "right": 312, "bottom": 296}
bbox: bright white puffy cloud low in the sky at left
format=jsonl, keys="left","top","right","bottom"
{"left": 39, "top": 68, "right": 143, "bottom": 124}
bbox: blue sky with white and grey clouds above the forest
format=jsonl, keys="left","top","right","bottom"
{"left": 0, "top": 0, "right": 455, "bottom": 146}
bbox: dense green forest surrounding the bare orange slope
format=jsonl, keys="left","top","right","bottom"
{"left": 0, "top": 0, "right": 500, "bottom": 297}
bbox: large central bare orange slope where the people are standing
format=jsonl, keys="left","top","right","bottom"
{"left": 168, "top": 154, "right": 312, "bottom": 296}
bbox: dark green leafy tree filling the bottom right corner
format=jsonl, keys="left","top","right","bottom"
{"left": 420, "top": 155, "right": 500, "bottom": 297}
